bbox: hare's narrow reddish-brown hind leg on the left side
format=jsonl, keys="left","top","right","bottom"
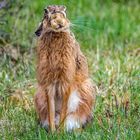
{"left": 34, "top": 89, "right": 49, "bottom": 131}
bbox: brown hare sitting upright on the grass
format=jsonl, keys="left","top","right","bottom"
{"left": 35, "top": 5, "right": 95, "bottom": 131}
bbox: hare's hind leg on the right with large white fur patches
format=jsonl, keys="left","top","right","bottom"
{"left": 65, "top": 79, "right": 95, "bottom": 131}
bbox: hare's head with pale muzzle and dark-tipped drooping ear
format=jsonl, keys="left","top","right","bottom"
{"left": 35, "top": 5, "right": 70, "bottom": 36}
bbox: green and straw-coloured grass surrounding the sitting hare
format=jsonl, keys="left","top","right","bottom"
{"left": 0, "top": 0, "right": 140, "bottom": 140}
